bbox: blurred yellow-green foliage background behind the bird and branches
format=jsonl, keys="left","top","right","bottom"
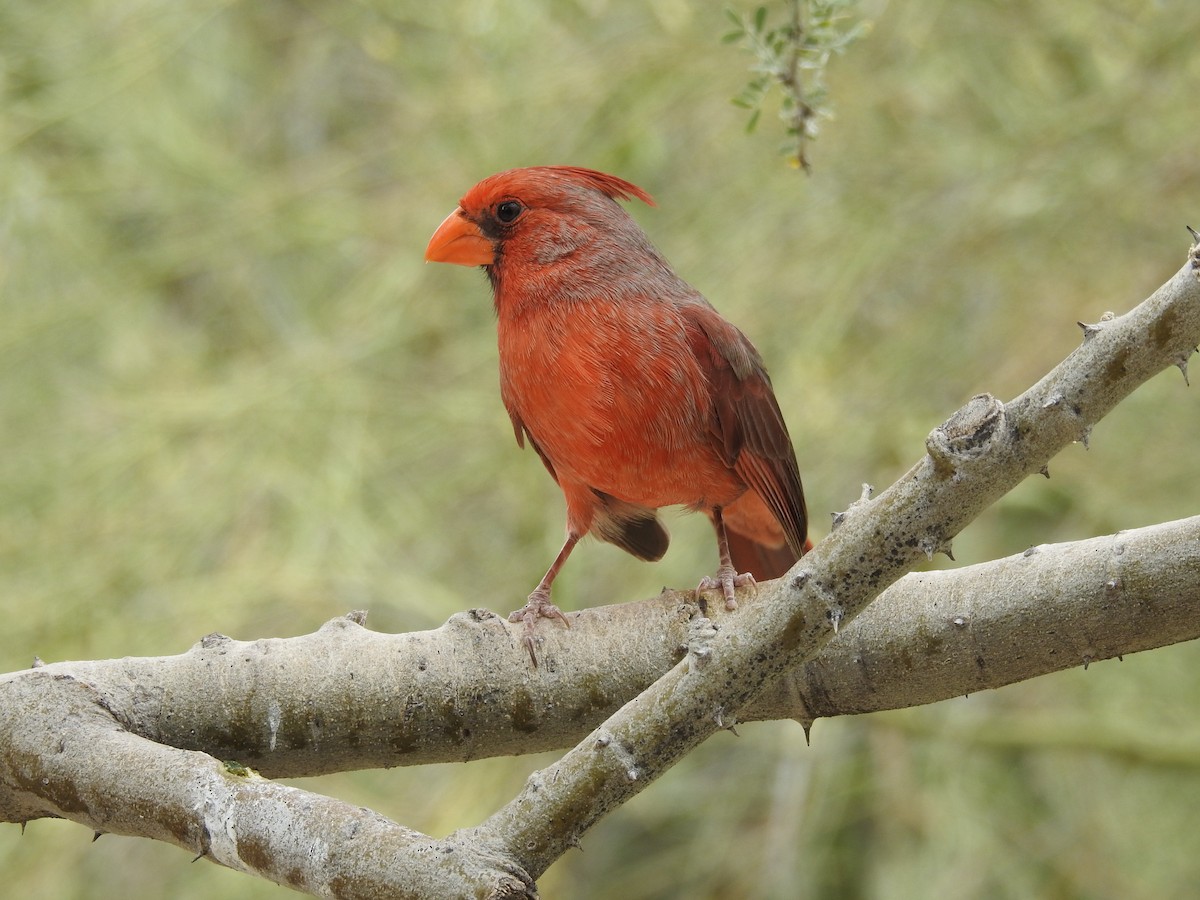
{"left": 0, "top": 0, "right": 1200, "bottom": 900}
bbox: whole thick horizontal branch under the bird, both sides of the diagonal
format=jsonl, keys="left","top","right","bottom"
{"left": 0, "top": 516, "right": 1200, "bottom": 801}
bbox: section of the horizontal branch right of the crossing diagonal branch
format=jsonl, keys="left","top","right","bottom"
{"left": 777, "top": 516, "right": 1200, "bottom": 721}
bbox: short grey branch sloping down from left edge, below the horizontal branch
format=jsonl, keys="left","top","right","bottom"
{"left": 0, "top": 668, "right": 535, "bottom": 900}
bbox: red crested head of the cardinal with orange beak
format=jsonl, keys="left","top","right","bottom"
{"left": 425, "top": 166, "right": 656, "bottom": 280}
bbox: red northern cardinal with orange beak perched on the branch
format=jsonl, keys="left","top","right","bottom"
{"left": 425, "top": 166, "right": 811, "bottom": 664}
